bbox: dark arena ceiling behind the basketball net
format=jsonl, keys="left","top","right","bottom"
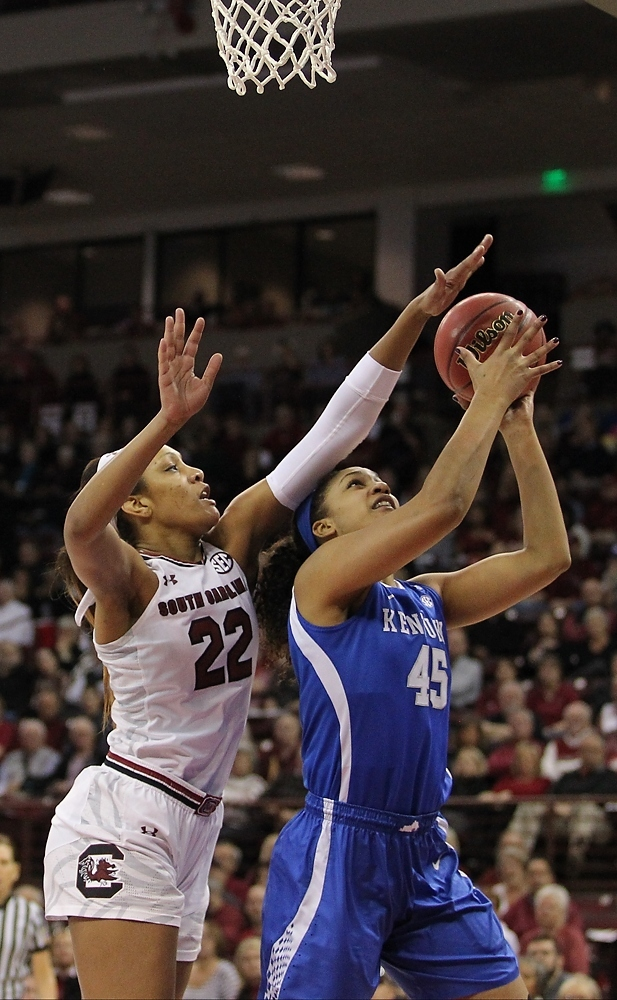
{"left": 0, "top": 0, "right": 617, "bottom": 230}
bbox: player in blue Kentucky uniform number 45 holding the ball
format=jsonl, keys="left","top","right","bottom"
{"left": 258, "top": 318, "right": 570, "bottom": 1000}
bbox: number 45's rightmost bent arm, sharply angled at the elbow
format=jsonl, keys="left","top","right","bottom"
{"left": 421, "top": 394, "right": 570, "bottom": 627}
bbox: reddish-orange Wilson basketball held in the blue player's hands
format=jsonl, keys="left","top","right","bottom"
{"left": 434, "top": 292, "right": 546, "bottom": 401}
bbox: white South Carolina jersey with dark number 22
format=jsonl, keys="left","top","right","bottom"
{"left": 94, "top": 544, "right": 258, "bottom": 796}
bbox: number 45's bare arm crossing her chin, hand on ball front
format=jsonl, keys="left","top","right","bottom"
{"left": 296, "top": 314, "right": 560, "bottom": 612}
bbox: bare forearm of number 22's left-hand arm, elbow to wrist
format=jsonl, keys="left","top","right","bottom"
{"left": 64, "top": 412, "right": 179, "bottom": 538}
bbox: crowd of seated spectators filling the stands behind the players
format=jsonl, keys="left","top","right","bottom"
{"left": 0, "top": 310, "right": 617, "bottom": 1000}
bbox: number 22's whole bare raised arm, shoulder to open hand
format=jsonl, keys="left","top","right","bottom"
{"left": 64, "top": 309, "right": 222, "bottom": 597}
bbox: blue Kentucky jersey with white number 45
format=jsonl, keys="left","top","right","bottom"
{"left": 289, "top": 583, "right": 452, "bottom": 815}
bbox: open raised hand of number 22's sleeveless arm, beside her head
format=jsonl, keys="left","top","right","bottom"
{"left": 158, "top": 309, "right": 223, "bottom": 426}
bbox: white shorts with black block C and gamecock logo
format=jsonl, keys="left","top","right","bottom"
{"left": 44, "top": 765, "right": 223, "bottom": 962}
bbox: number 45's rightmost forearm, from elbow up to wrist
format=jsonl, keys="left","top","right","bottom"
{"left": 504, "top": 421, "right": 570, "bottom": 572}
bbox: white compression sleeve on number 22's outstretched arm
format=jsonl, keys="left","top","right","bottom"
{"left": 266, "top": 354, "right": 401, "bottom": 510}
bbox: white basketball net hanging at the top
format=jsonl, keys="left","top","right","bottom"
{"left": 211, "top": 0, "right": 341, "bottom": 94}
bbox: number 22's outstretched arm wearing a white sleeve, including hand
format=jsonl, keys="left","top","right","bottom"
{"left": 210, "top": 234, "right": 493, "bottom": 576}
